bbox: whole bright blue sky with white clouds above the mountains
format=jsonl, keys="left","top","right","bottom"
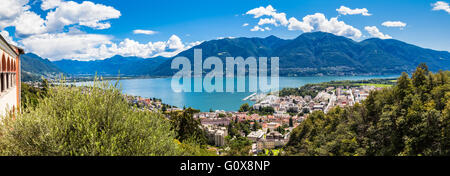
{"left": 0, "top": 0, "right": 450, "bottom": 60}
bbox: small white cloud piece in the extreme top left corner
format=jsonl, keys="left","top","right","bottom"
{"left": 0, "top": 0, "right": 30, "bottom": 30}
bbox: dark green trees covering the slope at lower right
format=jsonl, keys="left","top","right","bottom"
{"left": 285, "top": 65, "right": 450, "bottom": 156}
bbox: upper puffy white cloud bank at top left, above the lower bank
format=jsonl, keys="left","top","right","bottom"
{"left": 0, "top": 0, "right": 121, "bottom": 36}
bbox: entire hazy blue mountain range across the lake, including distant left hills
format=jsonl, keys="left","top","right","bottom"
{"left": 22, "top": 32, "right": 450, "bottom": 80}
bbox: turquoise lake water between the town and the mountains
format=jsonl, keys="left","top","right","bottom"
{"left": 97, "top": 75, "right": 397, "bottom": 111}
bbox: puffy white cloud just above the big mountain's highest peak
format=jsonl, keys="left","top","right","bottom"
{"left": 288, "top": 13, "right": 362, "bottom": 39}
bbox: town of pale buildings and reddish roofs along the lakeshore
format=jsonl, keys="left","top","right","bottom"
{"left": 124, "top": 80, "right": 390, "bottom": 155}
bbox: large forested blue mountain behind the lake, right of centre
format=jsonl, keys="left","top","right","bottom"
{"left": 154, "top": 32, "right": 450, "bottom": 76}
